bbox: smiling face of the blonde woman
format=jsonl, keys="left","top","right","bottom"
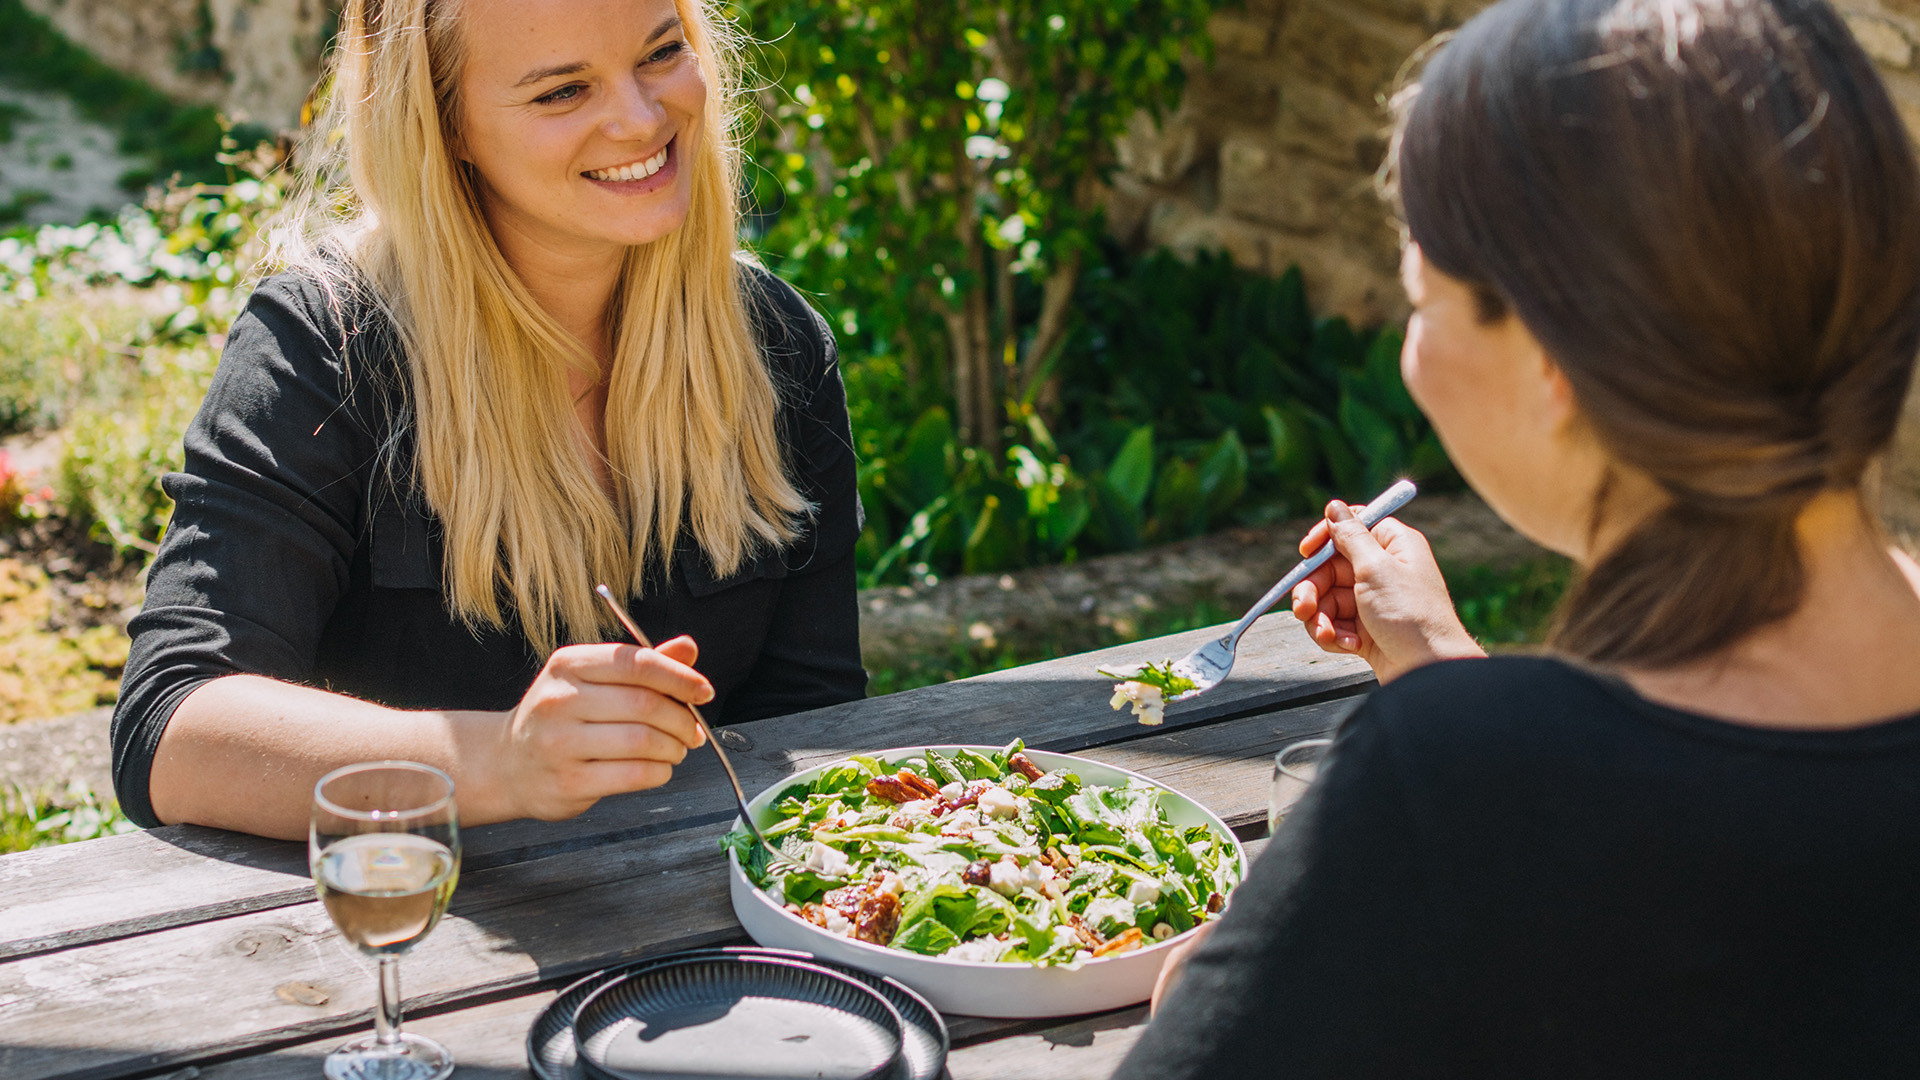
{"left": 457, "top": 0, "right": 707, "bottom": 256}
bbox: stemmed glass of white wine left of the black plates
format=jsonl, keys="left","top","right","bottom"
{"left": 307, "top": 761, "right": 461, "bottom": 1080}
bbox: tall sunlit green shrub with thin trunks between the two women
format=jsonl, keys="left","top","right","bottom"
{"left": 735, "top": 0, "right": 1213, "bottom": 459}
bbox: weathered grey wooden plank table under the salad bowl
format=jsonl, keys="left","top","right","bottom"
{"left": 0, "top": 619, "right": 1373, "bottom": 1080}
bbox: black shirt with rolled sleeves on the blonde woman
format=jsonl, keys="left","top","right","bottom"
{"left": 113, "top": 267, "right": 866, "bottom": 824}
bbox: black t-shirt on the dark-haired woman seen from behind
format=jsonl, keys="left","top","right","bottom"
{"left": 1119, "top": 657, "right": 1920, "bottom": 1080}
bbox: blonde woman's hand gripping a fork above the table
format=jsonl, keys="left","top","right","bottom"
{"left": 486, "top": 636, "right": 714, "bottom": 821}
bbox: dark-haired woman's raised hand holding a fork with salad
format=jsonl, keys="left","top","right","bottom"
{"left": 1294, "top": 500, "right": 1486, "bottom": 682}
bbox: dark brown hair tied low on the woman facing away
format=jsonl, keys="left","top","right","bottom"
{"left": 1392, "top": 0, "right": 1920, "bottom": 667}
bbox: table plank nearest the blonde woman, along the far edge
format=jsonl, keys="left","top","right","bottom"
{"left": 0, "top": 619, "right": 1371, "bottom": 959}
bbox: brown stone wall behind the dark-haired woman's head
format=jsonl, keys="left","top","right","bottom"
{"left": 1108, "top": 0, "right": 1920, "bottom": 536}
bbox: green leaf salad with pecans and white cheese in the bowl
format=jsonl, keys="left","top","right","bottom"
{"left": 722, "top": 740, "right": 1240, "bottom": 967}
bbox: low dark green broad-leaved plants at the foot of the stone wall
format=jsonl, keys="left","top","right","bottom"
{"left": 849, "top": 243, "right": 1457, "bottom": 584}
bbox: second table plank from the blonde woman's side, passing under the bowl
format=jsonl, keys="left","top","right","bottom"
{"left": 0, "top": 701, "right": 1320, "bottom": 1080}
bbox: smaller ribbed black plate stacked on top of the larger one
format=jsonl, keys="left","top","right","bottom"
{"left": 574, "top": 955, "right": 906, "bottom": 1080}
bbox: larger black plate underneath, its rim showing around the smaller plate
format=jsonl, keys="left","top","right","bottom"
{"left": 526, "top": 945, "right": 948, "bottom": 1080}
